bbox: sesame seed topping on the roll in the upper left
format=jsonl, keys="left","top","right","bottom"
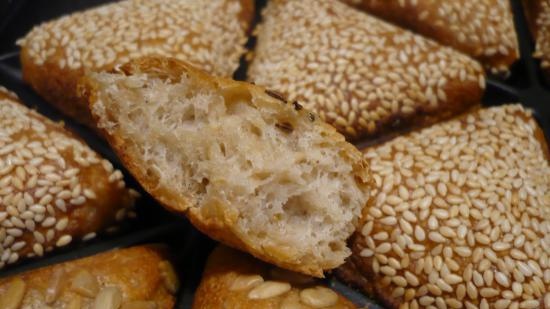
{"left": 18, "top": 0, "right": 248, "bottom": 81}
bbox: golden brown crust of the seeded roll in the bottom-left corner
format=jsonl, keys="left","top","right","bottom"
{"left": 0, "top": 246, "right": 175, "bottom": 309}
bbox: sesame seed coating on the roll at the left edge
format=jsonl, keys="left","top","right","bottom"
{"left": 0, "top": 90, "right": 140, "bottom": 267}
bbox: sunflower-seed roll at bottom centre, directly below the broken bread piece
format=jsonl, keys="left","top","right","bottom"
{"left": 192, "top": 246, "right": 357, "bottom": 309}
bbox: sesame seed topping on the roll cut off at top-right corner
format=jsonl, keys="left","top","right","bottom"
{"left": 533, "top": 0, "right": 550, "bottom": 69}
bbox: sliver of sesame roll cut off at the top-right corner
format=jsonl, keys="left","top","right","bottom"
{"left": 523, "top": 0, "right": 550, "bottom": 81}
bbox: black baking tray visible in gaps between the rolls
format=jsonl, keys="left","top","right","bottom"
{"left": 0, "top": 0, "right": 550, "bottom": 309}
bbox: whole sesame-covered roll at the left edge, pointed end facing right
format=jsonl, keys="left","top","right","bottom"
{"left": 0, "top": 87, "right": 137, "bottom": 268}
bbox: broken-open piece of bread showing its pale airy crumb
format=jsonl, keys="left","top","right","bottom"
{"left": 83, "top": 58, "right": 376, "bottom": 276}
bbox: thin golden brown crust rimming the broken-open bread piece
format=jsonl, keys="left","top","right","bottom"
{"left": 81, "top": 57, "right": 371, "bottom": 277}
